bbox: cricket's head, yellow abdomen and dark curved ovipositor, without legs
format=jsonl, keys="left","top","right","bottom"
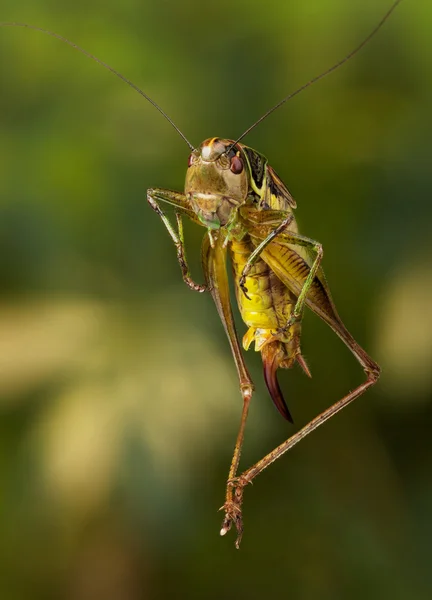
{"left": 175, "top": 138, "right": 308, "bottom": 421}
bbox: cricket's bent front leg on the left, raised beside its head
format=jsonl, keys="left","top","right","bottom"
{"left": 147, "top": 189, "right": 207, "bottom": 292}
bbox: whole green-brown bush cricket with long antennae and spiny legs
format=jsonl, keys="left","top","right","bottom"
{"left": 0, "top": 0, "right": 401, "bottom": 548}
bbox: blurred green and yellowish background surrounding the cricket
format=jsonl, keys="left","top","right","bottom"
{"left": 0, "top": 0, "right": 432, "bottom": 600}
